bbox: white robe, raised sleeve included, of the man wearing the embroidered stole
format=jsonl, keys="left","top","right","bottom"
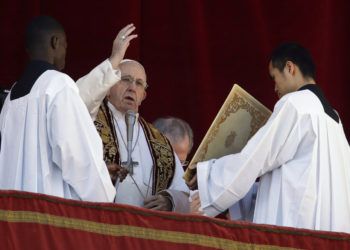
{"left": 77, "top": 60, "right": 189, "bottom": 212}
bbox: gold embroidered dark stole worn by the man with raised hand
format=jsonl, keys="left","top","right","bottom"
{"left": 95, "top": 99, "right": 175, "bottom": 195}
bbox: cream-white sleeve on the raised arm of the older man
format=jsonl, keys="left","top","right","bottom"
{"left": 76, "top": 59, "right": 120, "bottom": 120}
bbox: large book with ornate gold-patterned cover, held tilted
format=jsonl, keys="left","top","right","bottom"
{"left": 183, "top": 84, "right": 271, "bottom": 181}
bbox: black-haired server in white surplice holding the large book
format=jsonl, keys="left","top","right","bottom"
{"left": 188, "top": 43, "right": 350, "bottom": 232}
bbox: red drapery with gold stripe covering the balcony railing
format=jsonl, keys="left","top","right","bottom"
{"left": 0, "top": 191, "right": 350, "bottom": 250}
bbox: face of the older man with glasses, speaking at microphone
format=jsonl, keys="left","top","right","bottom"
{"left": 108, "top": 62, "right": 146, "bottom": 113}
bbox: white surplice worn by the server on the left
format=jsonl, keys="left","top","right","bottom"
{"left": 0, "top": 70, "right": 115, "bottom": 202}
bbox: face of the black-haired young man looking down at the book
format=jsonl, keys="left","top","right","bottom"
{"left": 269, "top": 61, "right": 296, "bottom": 98}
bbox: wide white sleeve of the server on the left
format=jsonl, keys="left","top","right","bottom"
{"left": 47, "top": 79, "right": 116, "bottom": 202}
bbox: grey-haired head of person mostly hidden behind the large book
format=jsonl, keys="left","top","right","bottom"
{"left": 153, "top": 116, "right": 193, "bottom": 168}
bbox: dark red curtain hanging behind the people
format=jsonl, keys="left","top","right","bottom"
{"left": 0, "top": 0, "right": 350, "bottom": 152}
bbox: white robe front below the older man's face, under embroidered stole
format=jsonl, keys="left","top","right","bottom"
{"left": 108, "top": 103, "right": 189, "bottom": 210}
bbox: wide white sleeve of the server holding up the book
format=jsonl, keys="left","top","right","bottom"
{"left": 197, "top": 99, "right": 310, "bottom": 216}
